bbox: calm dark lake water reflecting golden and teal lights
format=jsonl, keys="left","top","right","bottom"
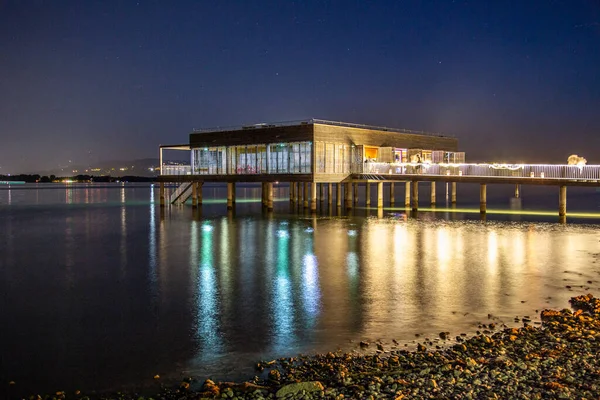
{"left": 0, "top": 184, "right": 600, "bottom": 394}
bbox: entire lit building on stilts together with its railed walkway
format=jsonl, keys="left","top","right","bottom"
{"left": 159, "top": 120, "right": 600, "bottom": 219}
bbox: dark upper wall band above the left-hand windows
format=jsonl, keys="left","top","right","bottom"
{"left": 190, "top": 124, "right": 314, "bottom": 148}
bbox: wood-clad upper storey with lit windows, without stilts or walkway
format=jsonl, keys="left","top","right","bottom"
{"left": 183, "top": 123, "right": 458, "bottom": 182}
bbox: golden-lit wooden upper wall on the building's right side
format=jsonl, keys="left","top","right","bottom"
{"left": 314, "top": 124, "right": 458, "bottom": 151}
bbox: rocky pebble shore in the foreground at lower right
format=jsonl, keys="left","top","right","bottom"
{"left": 10, "top": 294, "right": 600, "bottom": 400}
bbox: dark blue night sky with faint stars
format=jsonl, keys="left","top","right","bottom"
{"left": 0, "top": 0, "right": 600, "bottom": 174}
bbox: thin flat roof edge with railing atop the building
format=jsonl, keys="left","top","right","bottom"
{"left": 192, "top": 118, "right": 454, "bottom": 138}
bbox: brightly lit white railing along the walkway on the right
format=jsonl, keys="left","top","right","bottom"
{"left": 352, "top": 162, "right": 600, "bottom": 180}
